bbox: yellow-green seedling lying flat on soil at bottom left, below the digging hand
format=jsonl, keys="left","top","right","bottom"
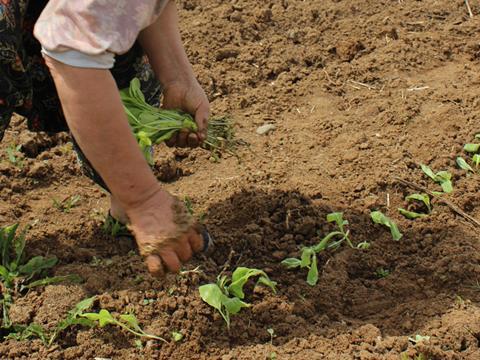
{"left": 79, "top": 309, "right": 167, "bottom": 342}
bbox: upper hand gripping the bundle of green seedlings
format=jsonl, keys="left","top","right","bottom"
{"left": 162, "top": 78, "right": 210, "bottom": 147}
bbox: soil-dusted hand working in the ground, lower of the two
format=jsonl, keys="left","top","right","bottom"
{"left": 126, "top": 188, "right": 204, "bottom": 277}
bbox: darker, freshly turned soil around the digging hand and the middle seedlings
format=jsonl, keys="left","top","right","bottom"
{"left": 24, "top": 189, "right": 480, "bottom": 347}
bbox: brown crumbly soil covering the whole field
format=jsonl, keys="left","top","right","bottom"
{"left": 0, "top": 0, "right": 480, "bottom": 360}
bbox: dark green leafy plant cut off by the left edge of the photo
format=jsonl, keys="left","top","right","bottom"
{"left": 0, "top": 224, "right": 81, "bottom": 331}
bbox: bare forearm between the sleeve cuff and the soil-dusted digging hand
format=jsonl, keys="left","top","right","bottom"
{"left": 47, "top": 58, "right": 158, "bottom": 207}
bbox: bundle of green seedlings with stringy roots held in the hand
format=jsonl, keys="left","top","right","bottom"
{"left": 120, "top": 78, "right": 238, "bottom": 164}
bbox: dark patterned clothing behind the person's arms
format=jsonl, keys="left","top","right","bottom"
{"left": 0, "top": 0, "right": 160, "bottom": 191}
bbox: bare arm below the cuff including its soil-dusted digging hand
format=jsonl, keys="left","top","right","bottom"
{"left": 46, "top": 56, "right": 202, "bottom": 275}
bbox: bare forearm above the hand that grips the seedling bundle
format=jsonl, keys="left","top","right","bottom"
{"left": 139, "top": 1, "right": 195, "bottom": 85}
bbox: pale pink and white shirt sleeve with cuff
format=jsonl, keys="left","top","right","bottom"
{"left": 34, "top": 0, "right": 170, "bottom": 69}
